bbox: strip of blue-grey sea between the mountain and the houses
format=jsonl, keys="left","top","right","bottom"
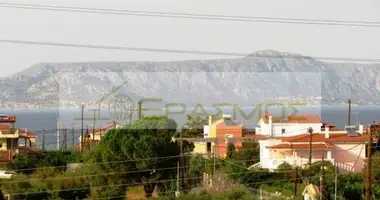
{"left": 0, "top": 105, "right": 380, "bottom": 149}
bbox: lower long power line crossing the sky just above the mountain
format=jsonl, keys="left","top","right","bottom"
{"left": 0, "top": 39, "right": 380, "bottom": 63}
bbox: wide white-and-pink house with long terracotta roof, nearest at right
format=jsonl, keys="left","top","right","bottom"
{"left": 259, "top": 125, "right": 376, "bottom": 172}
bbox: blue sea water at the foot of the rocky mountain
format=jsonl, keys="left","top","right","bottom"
{"left": 0, "top": 106, "right": 380, "bottom": 148}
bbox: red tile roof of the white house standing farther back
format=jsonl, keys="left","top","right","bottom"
{"left": 261, "top": 115, "right": 322, "bottom": 124}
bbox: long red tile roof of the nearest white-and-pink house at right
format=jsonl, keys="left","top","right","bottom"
{"left": 281, "top": 133, "right": 368, "bottom": 143}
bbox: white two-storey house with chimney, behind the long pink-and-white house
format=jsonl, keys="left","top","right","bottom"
{"left": 256, "top": 114, "right": 323, "bottom": 137}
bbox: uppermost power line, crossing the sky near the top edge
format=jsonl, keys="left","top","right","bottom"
{"left": 0, "top": 2, "right": 380, "bottom": 27}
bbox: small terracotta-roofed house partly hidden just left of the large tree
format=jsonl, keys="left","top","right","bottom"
{"left": 79, "top": 122, "right": 121, "bottom": 148}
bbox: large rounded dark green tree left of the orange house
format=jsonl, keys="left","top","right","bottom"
{"left": 87, "top": 117, "right": 194, "bottom": 197}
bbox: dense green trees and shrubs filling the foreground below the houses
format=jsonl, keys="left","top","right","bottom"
{"left": 0, "top": 117, "right": 380, "bottom": 200}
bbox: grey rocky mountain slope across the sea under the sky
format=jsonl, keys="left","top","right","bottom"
{"left": 0, "top": 51, "right": 380, "bottom": 106}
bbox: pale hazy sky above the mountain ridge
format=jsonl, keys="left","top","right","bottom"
{"left": 0, "top": 0, "right": 380, "bottom": 77}
